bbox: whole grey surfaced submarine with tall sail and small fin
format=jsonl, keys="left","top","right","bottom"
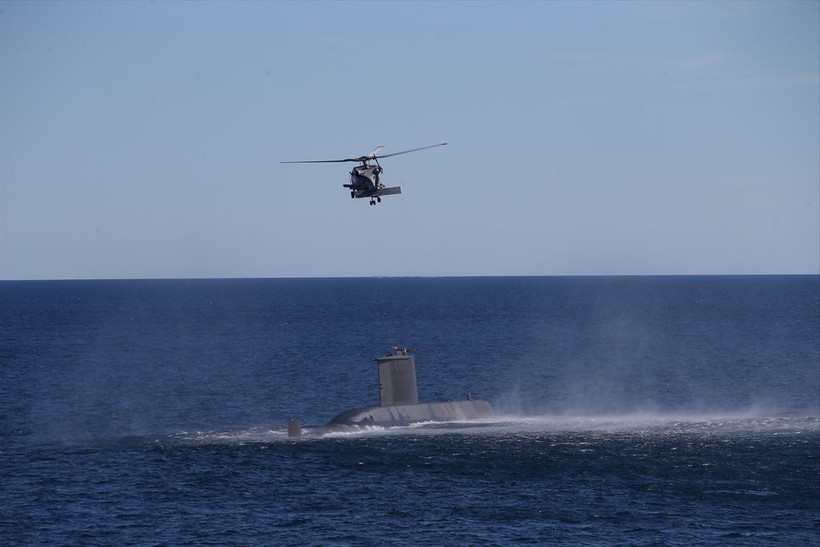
{"left": 288, "top": 346, "right": 495, "bottom": 437}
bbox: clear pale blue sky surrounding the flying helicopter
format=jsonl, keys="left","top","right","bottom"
{"left": 0, "top": 1, "right": 820, "bottom": 280}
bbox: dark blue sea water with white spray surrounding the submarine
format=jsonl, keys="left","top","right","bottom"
{"left": 0, "top": 276, "right": 820, "bottom": 546}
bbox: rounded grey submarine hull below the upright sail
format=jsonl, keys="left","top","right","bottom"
{"left": 327, "top": 400, "right": 494, "bottom": 427}
